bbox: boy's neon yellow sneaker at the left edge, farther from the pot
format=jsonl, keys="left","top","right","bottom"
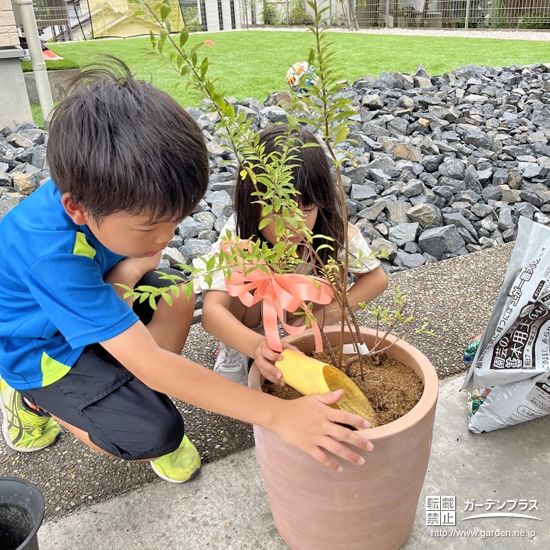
{"left": 0, "top": 379, "right": 61, "bottom": 453}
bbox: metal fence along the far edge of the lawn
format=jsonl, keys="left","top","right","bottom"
{"left": 24, "top": 0, "right": 550, "bottom": 41}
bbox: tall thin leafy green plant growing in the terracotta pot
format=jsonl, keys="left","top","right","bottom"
{"left": 124, "top": 0, "right": 429, "bottom": 382}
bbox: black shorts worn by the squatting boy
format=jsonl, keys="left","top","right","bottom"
{"left": 21, "top": 269, "right": 190, "bottom": 460}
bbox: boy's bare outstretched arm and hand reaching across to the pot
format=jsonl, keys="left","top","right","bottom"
{"left": 101, "top": 322, "right": 372, "bottom": 471}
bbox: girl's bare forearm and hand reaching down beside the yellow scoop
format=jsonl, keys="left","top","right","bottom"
{"left": 202, "top": 290, "right": 299, "bottom": 386}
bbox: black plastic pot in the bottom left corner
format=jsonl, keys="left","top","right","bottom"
{"left": 0, "top": 477, "right": 44, "bottom": 550}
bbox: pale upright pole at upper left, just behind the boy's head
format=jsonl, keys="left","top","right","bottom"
{"left": 14, "top": 0, "right": 53, "bottom": 128}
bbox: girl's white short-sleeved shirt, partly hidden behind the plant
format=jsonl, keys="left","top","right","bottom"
{"left": 193, "top": 214, "right": 380, "bottom": 294}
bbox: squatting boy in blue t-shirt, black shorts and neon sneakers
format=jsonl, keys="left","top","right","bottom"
{"left": 0, "top": 60, "right": 372, "bottom": 483}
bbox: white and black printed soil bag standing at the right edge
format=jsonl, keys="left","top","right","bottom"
{"left": 462, "top": 217, "right": 550, "bottom": 433}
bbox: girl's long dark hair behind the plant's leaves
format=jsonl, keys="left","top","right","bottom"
{"left": 234, "top": 125, "right": 344, "bottom": 263}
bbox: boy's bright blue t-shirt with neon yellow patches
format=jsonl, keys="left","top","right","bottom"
{"left": 0, "top": 180, "right": 138, "bottom": 390}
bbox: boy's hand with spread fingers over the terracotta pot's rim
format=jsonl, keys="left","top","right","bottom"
{"left": 270, "top": 390, "right": 373, "bottom": 472}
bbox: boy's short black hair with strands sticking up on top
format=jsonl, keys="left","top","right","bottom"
{"left": 47, "top": 56, "right": 209, "bottom": 222}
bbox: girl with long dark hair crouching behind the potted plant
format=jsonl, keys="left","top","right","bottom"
{"left": 195, "top": 126, "right": 388, "bottom": 386}
